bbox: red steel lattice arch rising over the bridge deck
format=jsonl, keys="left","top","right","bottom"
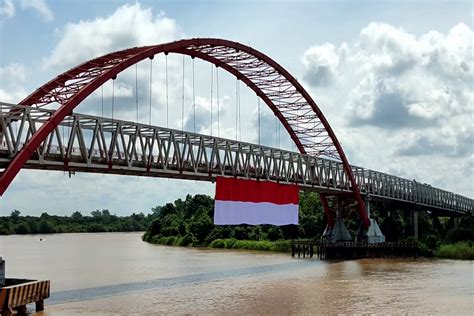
{"left": 0, "top": 38, "right": 370, "bottom": 227}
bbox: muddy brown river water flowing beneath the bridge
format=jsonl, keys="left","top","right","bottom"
{"left": 0, "top": 233, "right": 474, "bottom": 316}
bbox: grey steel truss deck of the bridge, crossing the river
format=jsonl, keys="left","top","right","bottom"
{"left": 0, "top": 102, "right": 474, "bottom": 215}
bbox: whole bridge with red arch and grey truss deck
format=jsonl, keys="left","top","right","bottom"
{"left": 0, "top": 39, "right": 474, "bottom": 237}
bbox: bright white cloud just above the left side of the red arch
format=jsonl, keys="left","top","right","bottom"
{"left": 44, "top": 3, "right": 182, "bottom": 69}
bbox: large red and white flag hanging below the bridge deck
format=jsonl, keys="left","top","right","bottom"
{"left": 214, "top": 177, "right": 299, "bottom": 225}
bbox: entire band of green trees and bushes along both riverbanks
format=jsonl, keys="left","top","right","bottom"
{"left": 0, "top": 193, "right": 474, "bottom": 260}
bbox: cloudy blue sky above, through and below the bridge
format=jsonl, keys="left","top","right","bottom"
{"left": 0, "top": 0, "right": 474, "bottom": 215}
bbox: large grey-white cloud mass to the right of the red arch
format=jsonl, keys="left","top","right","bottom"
{"left": 303, "top": 23, "right": 474, "bottom": 196}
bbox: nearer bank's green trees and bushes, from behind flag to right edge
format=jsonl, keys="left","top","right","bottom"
{"left": 143, "top": 193, "right": 474, "bottom": 259}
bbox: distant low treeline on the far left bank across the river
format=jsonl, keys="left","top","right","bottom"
{"left": 0, "top": 210, "right": 152, "bottom": 235}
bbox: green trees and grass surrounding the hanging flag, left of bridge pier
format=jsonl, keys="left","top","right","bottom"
{"left": 143, "top": 194, "right": 326, "bottom": 247}
